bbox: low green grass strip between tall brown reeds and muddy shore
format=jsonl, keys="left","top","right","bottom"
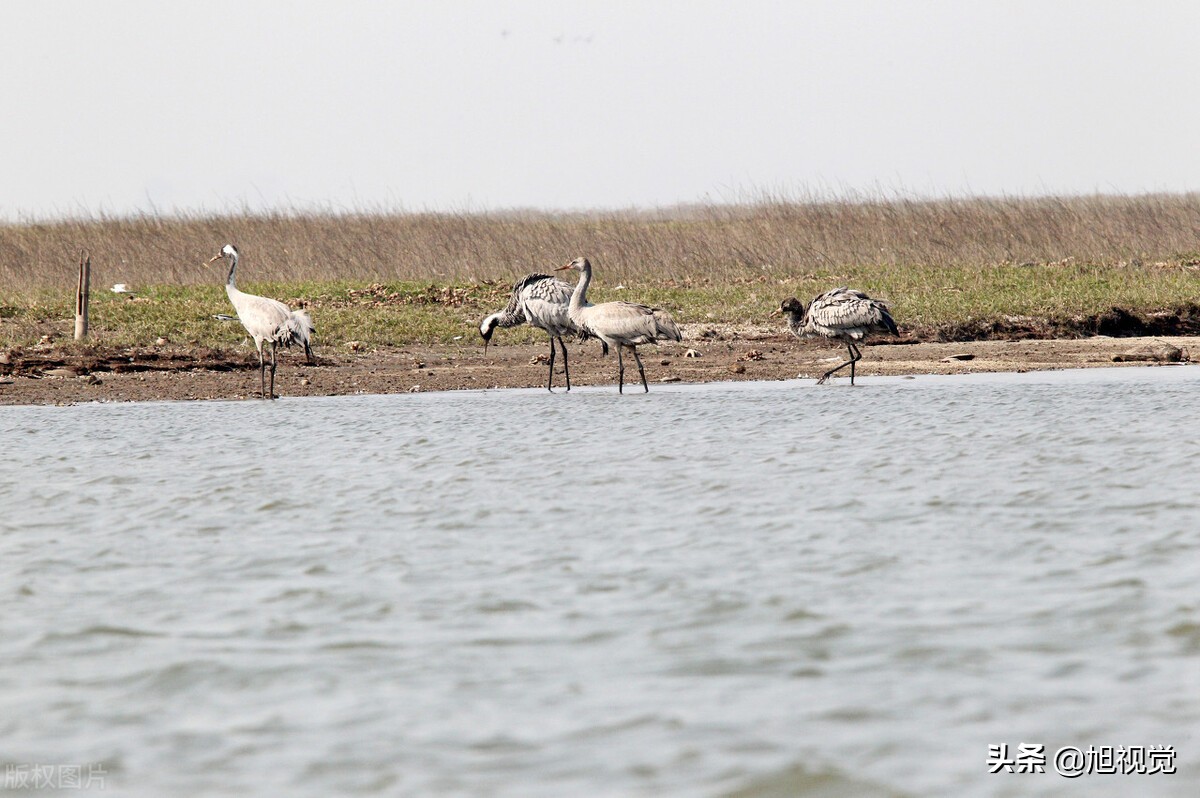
{"left": 7, "top": 257, "right": 1200, "bottom": 347}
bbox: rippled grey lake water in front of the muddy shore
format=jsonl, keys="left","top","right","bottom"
{"left": 0, "top": 366, "right": 1200, "bottom": 797}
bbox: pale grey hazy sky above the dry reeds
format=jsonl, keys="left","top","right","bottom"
{"left": 0, "top": 0, "right": 1200, "bottom": 220}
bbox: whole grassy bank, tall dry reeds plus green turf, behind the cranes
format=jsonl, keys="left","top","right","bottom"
{"left": 0, "top": 194, "right": 1200, "bottom": 343}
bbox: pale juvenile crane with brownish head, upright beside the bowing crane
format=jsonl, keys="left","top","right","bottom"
{"left": 558, "top": 258, "right": 683, "bottom": 394}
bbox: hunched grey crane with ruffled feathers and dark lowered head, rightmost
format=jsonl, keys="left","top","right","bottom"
{"left": 775, "top": 287, "right": 900, "bottom": 385}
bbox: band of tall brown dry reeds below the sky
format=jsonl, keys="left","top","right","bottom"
{"left": 0, "top": 194, "right": 1200, "bottom": 294}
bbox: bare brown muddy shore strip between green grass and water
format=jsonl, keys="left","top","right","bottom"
{"left": 0, "top": 328, "right": 1200, "bottom": 404}
